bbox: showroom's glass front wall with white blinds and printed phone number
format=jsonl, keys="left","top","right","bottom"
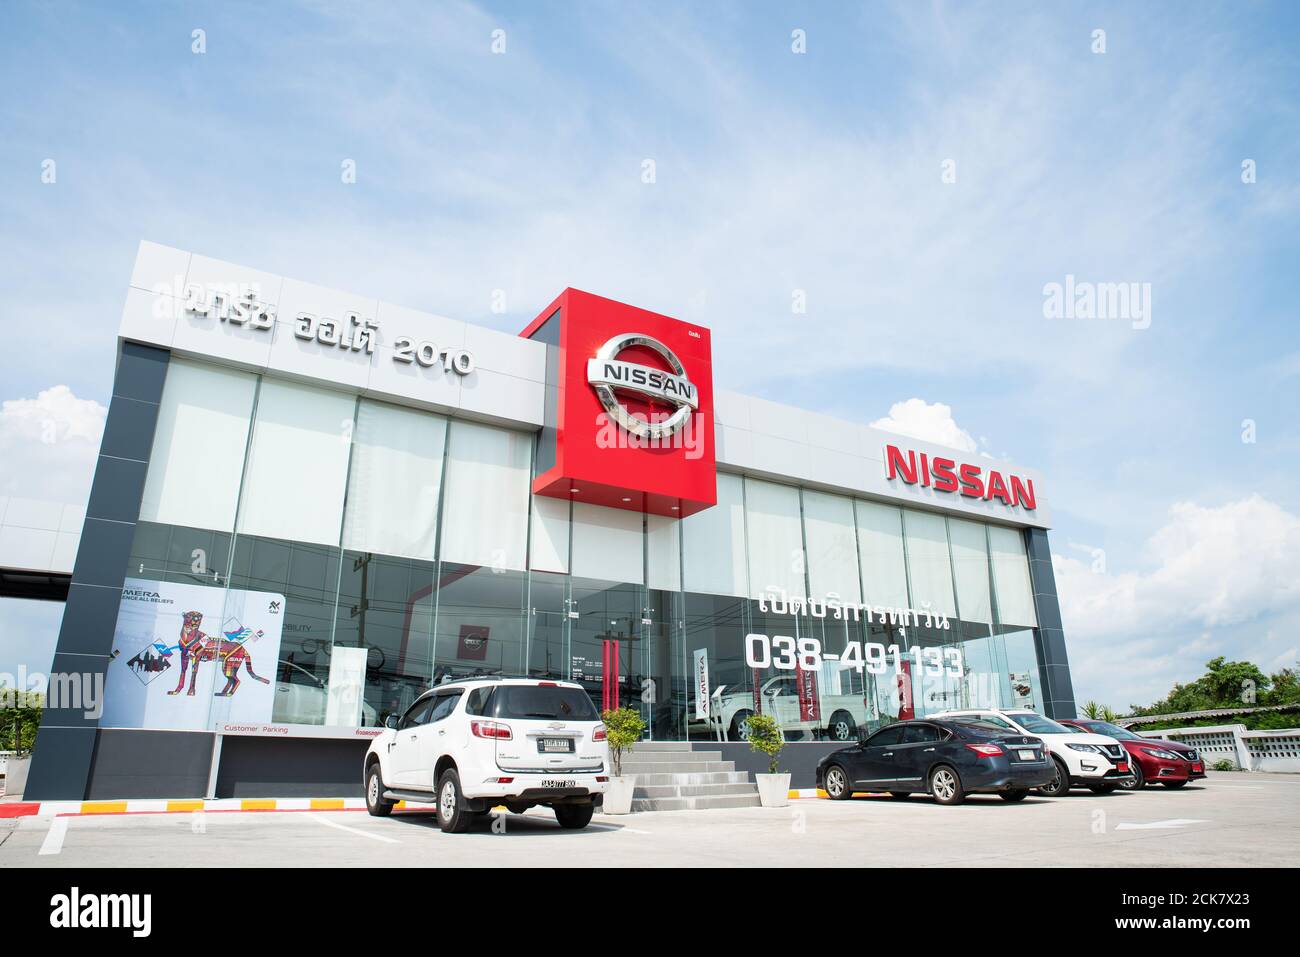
{"left": 111, "top": 359, "right": 1043, "bottom": 740}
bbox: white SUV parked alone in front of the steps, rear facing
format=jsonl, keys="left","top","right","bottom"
{"left": 364, "top": 677, "right": 610, "bottom": 831}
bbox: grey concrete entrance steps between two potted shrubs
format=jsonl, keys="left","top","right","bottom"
{"left": 623, "top": 741, "right": 761, "bottom": 811}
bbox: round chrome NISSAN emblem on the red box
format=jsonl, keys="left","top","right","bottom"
{"left": 586, "top": 333, "right": 699, "bottom": 439}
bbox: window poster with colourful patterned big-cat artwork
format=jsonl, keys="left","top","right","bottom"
{"left": 100, "top": 579, "right": 285, "bottom": 731}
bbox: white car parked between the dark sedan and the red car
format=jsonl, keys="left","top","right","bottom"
{"left": 927, "top": 709, "right": 1132, "bottom": 797}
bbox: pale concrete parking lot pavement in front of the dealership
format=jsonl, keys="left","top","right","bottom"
{"left": 0, "top": 774, "right": 1300, "bottom": 867}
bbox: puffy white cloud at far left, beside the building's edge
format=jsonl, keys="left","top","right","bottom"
{"left": 0, "top": 385, "right": 108, "bottom": 505}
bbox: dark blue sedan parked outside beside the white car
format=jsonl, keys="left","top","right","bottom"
{"left": 816, "top": 720, "right": 1056, "bottom": 804}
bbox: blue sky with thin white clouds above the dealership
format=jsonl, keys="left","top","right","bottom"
{"left": 0, "top": 3, "right": 1300, "bottom": 707}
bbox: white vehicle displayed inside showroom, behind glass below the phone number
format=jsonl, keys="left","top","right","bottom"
{"left": 692, "top": 671, "right": 868, "bottom": 741}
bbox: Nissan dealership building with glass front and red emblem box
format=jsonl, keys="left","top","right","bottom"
{"left": 27, "top": 243, "right": 1075, "bottom": 800}
